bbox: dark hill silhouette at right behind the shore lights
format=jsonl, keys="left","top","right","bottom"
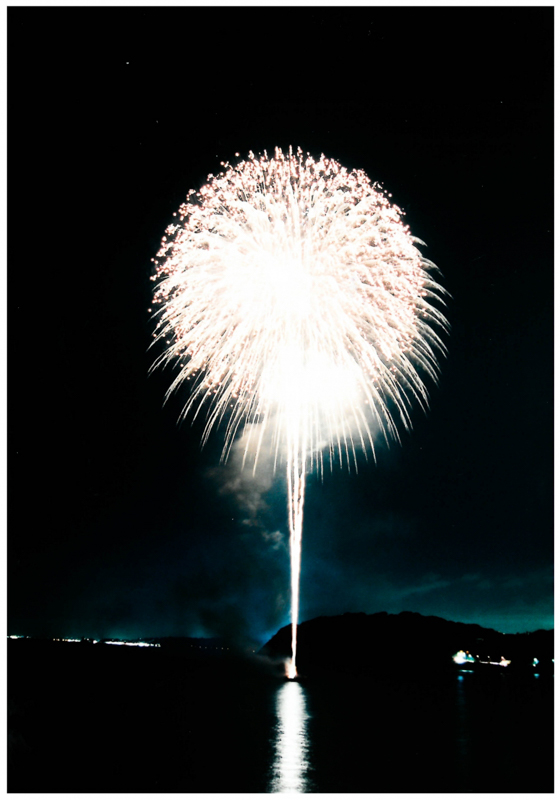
{"left": 261, "top": 611, "right": 554, "bottom": 675}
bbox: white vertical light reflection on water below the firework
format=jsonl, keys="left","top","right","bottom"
{"left": 268, "top": 681, "right": 311, "bottom": 793}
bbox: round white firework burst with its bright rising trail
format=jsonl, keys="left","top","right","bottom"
{"left": 152, "top": 148, "right": 447, "bottom": 677}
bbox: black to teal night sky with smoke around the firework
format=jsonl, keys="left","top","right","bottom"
{"left": 7, "top": 7, "right": 553, "bottom": 642}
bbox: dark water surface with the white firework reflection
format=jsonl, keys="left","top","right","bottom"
{"left": 8, "top": 641, "right": 554, "bottom": 793}
